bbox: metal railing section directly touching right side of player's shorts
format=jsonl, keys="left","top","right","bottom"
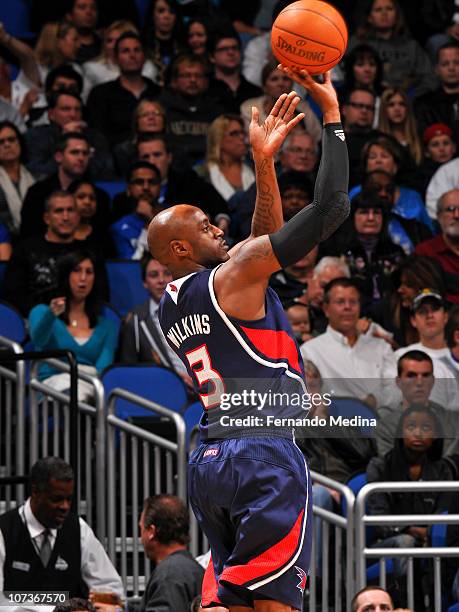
{"left": 309, "top": 471, "right": 355, "bottom": 612}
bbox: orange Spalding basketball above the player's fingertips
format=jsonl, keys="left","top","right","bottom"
{"left": 271, "top": 0, "right": 347, "bottom": 74}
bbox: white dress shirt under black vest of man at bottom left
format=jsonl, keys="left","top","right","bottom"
{"left": 0, "top": 498, "right": 124, "bottom": 612}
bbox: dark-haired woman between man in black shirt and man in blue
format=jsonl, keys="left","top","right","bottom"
{"left": 68, "top": 179, "right": 115, "bottom": 259}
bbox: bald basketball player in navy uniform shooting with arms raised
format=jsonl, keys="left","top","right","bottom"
{"left": 148, "top": 71, "right": 349, "bottom": 612}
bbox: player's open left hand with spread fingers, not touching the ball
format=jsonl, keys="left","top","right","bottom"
{"left": 249, "top": 91, "right": 304, "bottom": 156}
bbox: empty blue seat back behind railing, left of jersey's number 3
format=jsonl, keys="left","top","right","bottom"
{"left": 101, "top": 364, "right": 187, "bottom": 419}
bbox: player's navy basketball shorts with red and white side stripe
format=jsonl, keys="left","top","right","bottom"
{"left": 188, "top": 436, "right": 313, "bottom": 610}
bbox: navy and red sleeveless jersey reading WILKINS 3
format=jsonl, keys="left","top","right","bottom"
{"left": 159, "top": 268, "right": 307, "bottom": 437}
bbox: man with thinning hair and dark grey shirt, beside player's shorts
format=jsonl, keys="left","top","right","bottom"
{"left": 139, "top": 495, "right": 204, "bottom": 612}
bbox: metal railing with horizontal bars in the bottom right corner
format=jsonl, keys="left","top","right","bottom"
{"left": 355, "top": 481, "right": 459, "bottom": 612}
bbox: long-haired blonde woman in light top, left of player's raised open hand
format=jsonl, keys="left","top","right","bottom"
{"left": 195, "top": 115, "right": 255, "bottom": 201}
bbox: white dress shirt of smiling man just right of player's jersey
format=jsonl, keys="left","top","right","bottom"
{"left": 300, "top": 325, "right": 395, "bottom": 404}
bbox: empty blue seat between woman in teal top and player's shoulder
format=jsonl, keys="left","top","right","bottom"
{"left": 105, "top": 259, "right": 148, "bottom": 316}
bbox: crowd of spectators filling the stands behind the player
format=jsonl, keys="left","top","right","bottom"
{"left": 0, "top": 0, "right": 459, "bottom": 608}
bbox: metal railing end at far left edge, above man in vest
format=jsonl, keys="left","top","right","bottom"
{"left": 0, "top": 336, "right": 25, "bottom": 512}
